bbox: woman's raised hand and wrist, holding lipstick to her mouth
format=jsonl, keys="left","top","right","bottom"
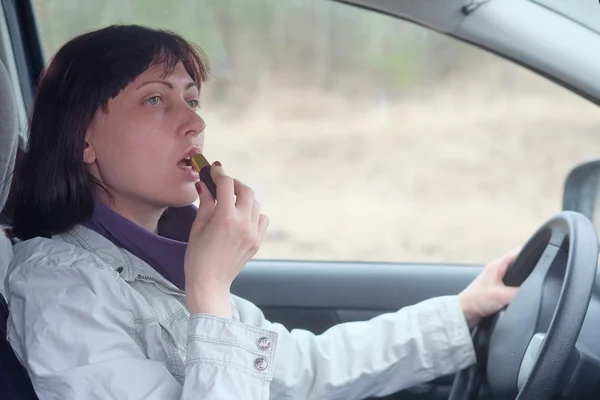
{"left": 184, "top": 162, "right": 269, "bottom": 318}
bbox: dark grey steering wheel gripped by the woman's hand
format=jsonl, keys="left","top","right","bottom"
{"left": 449, "top": 211, "right": 598, "bottom": 400}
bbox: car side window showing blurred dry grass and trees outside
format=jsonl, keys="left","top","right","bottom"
{"left": 33, "top": 0, "right": 600, "bottom": 263}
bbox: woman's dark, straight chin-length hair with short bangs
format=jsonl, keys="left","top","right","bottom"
{"left": 12, "top": 25, "right": 208, "bottom": 240}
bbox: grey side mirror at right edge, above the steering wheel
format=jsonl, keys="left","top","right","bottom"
{"left": 562, "top": 159, "right": 600, "bottom": 232}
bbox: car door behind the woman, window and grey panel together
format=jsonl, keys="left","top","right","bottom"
{"left": 3, "top": 0, "right": 600, "bottom": 400}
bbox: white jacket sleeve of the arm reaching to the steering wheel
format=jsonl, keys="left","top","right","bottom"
{"left": 234, "top": 296, "right": 475, "bottom": 400}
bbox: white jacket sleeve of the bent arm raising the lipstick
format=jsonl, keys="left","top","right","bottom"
{"left": 6, "top": 257, "right": 277, "bottom": 400}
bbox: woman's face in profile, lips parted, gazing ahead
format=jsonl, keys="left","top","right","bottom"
{"left": 84, "top": 63, "right": 206, "bottom": 208}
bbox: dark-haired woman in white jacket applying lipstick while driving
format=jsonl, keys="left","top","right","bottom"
{"left": 5, "top": 26, "right": 516, "bottom": 400}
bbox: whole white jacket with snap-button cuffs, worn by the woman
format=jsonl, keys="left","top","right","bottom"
{"left": 5, "top": 226, "right": 475, "bottom": 400}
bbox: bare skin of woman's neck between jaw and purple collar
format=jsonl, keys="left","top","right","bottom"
{"left": 99, "top": 191, "right": 165, "bottom": 233}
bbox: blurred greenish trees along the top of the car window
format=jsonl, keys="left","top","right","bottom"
{"left": 33, "top": 0, "right": 488, "bottom": 101}
